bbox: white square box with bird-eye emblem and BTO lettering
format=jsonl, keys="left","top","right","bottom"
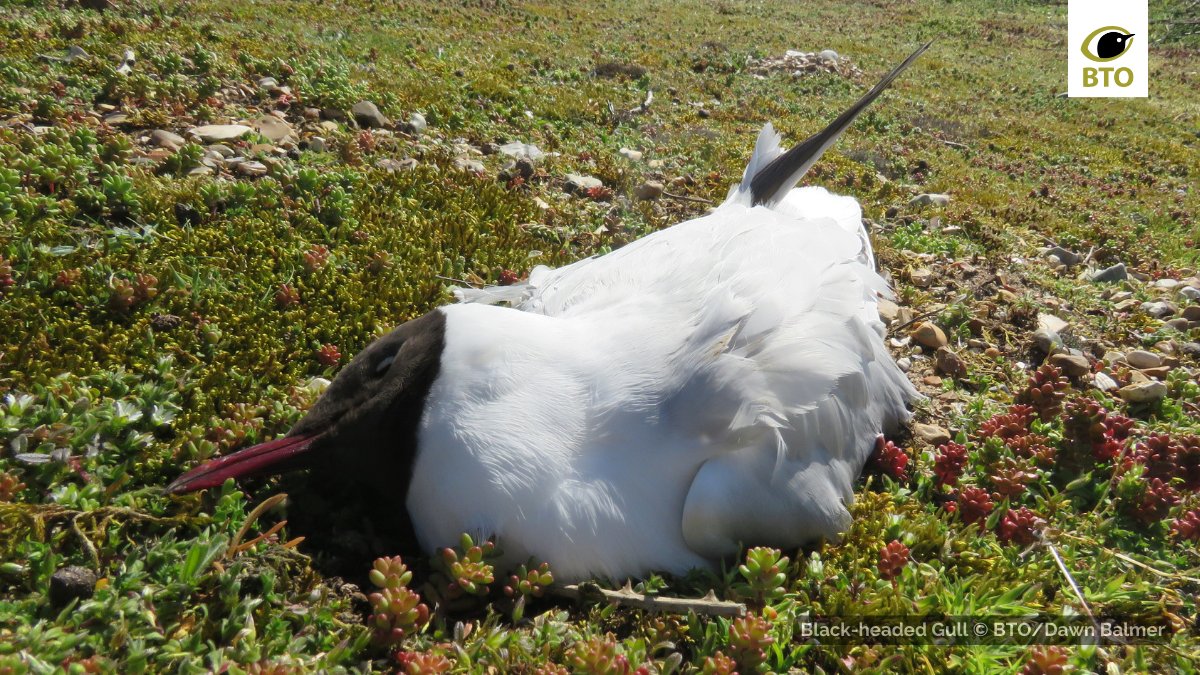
{"left": 1067, "top": 0, "right": 1150, "bottom": 97}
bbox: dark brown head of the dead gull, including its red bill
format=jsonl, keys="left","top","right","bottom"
{"left": 167, "top": 310, "right": 445, "bottom": 492}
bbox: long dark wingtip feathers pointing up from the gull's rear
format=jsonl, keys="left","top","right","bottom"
{"left": 750, "top": 41, "right": 934, "bottom": 205}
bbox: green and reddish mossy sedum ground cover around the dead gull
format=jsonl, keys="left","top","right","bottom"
{"left": 0, "top": 0, "right": 1200, "bottom": 673}
